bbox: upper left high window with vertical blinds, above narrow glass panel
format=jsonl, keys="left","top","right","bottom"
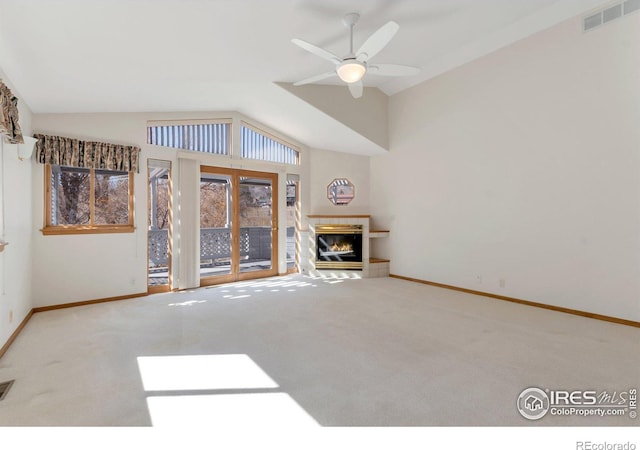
{"left": 147, "top": 121, "right": 231, "bottom": 155}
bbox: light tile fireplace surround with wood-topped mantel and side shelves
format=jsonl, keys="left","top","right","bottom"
{"left": 301, "top": 214, "right": 389, "bottom": 278}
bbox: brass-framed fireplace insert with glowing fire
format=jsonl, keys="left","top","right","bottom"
{"left": 315, "top": 225, "right": 363, "bottom": 269}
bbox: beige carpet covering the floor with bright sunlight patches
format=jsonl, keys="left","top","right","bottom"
{"left": 0, "top": 275, "right": 640, "bottom": 427}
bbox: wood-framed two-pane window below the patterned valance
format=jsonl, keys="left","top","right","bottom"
{"left": 43, "top": 164, "right": 133, "bottom": 234}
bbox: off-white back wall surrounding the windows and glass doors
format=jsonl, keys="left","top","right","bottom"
{"left": 33, "top": 112, "right": 308, "bottom": 306}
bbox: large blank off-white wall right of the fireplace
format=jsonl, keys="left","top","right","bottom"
{"left": 371, "top": 10, "right": 640, "bottom": 321}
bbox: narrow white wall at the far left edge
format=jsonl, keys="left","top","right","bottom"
{"left": 0, "top": 69, "right": 33, "bottom": 348}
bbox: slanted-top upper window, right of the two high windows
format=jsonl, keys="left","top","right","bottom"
{"left": 240, "top": 123, "right": 300, "bottom": 165}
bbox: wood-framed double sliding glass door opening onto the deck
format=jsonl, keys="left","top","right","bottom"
{"left": 200, "top": 166, "right": 278, "bottom": 286}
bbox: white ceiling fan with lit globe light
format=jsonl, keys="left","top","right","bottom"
{"left": 291, "top": 13, "right": 420, "bottom": 98}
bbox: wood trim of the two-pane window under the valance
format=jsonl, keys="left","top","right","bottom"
{"left": 40, "top": 164, "right": 136, "bottom": 236}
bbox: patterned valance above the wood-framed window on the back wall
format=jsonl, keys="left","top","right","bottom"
{"left": 33, "top": 134, "right": 140, "bottom": 172}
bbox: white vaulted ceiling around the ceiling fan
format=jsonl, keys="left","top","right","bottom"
{"left": 0, "top": 0, "right": 603, "bottom": 154}
